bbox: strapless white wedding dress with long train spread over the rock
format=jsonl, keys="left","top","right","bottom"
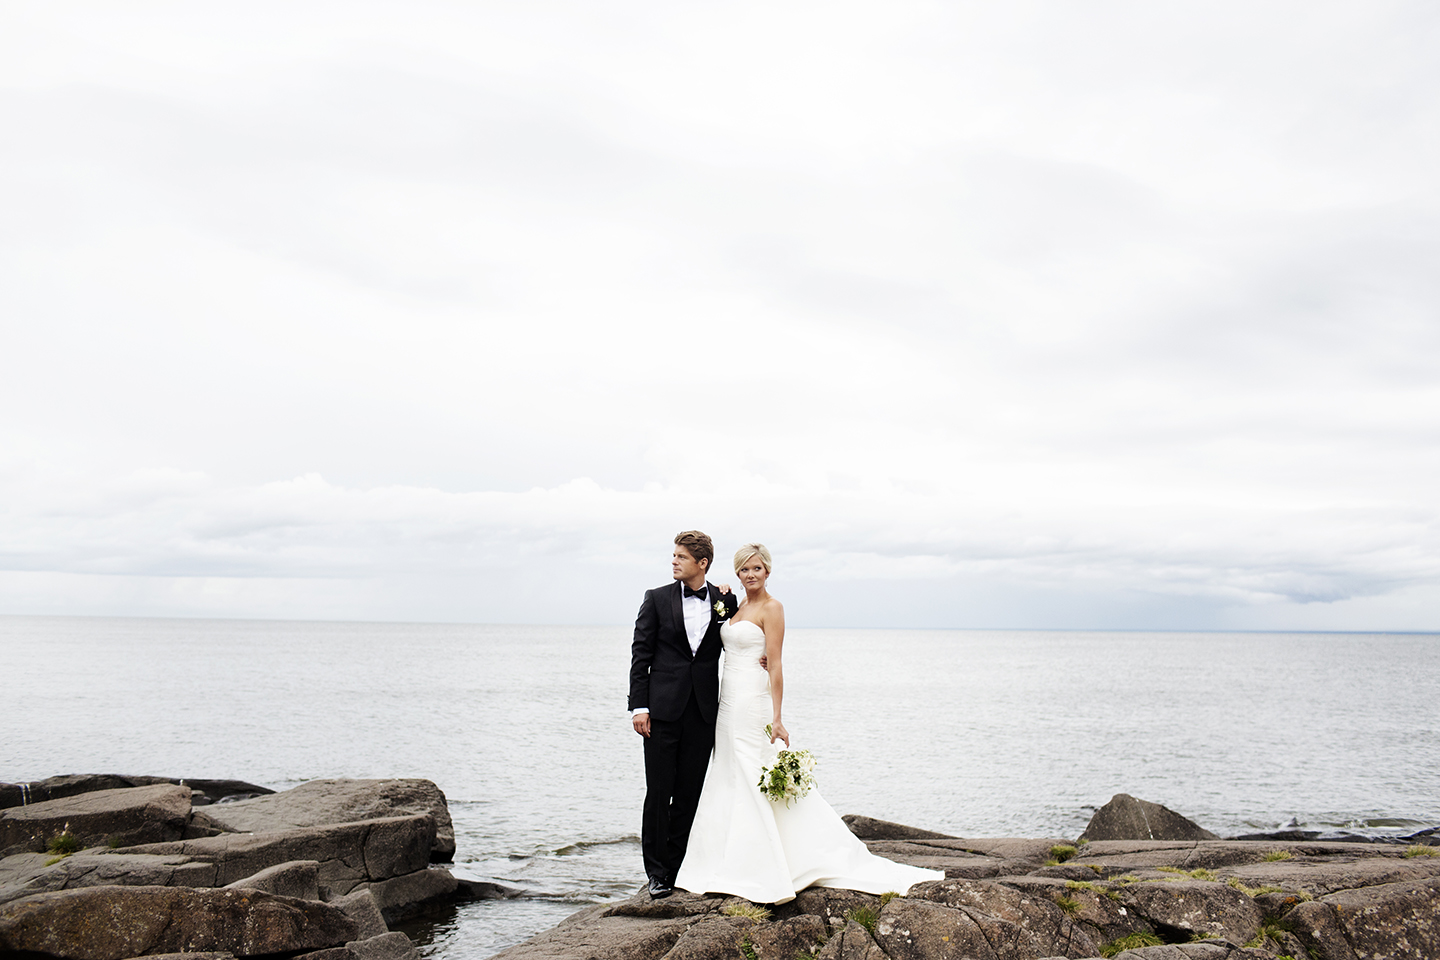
{"left": 675, "top": 620, "right": 945, "bottom": 904}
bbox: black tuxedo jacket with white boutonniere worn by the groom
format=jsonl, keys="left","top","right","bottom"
{"left": 629, "top": 580, "right": 739, "bottom": 724}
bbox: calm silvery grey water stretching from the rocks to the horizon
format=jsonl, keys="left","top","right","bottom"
{"left": 0, "top": 617, "right": 1440, "bottom": 960}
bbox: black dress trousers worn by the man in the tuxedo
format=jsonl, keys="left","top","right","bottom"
{"left": 639, "top": 691, "right": 716, "bottom": 882}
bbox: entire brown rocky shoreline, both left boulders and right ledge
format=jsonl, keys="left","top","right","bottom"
{"left": 0, "top": 774, "right": 1440, "bottom": 960}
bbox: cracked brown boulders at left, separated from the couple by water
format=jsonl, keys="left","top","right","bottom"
{"left": 0, "top": 774, "right": 514, "bottom": 960}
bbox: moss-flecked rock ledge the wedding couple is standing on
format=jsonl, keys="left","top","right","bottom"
{"left": 492, "top": 794, "right": 1440, "bottom": 960}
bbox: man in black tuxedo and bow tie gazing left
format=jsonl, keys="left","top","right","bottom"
{"left": 629, "top": 530, "right": 739, "bottom": 898}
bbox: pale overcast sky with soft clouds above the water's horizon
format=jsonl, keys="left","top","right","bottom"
{"left": 0, "top": 0, "right": 1440, "bottom": 629}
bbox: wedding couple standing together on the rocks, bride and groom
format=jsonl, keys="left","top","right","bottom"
{"left": 629, "top": 530, "right": 943, "bottom": 904}
